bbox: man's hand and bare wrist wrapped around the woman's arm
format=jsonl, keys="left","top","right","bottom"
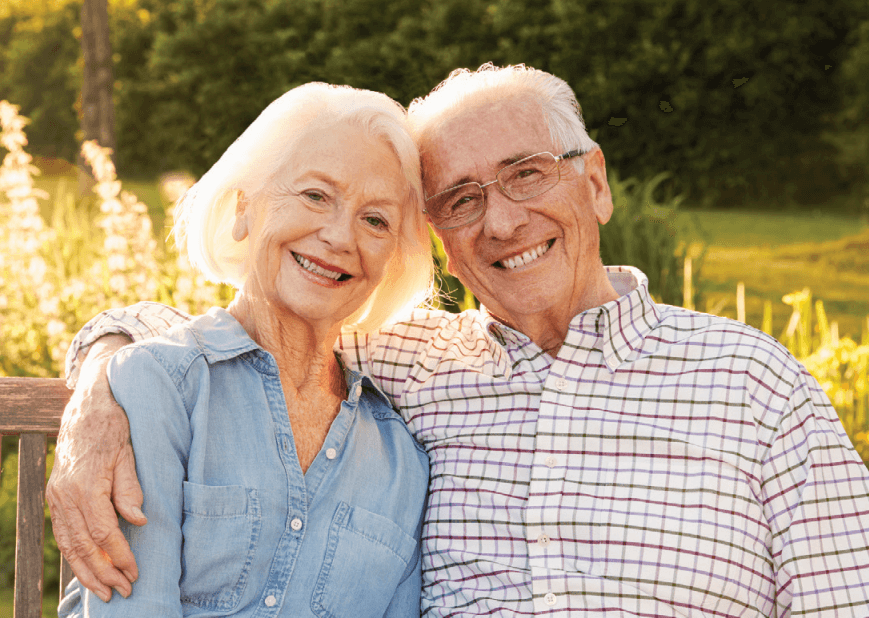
{"left": 45, "top": 335, "right": 148, "bottom": 602}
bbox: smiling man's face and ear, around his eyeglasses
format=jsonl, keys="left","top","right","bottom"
{"left": 422, "top": 99, "right": 612, "bottom": 330}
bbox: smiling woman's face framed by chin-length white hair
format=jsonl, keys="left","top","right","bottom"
{"left": 238, "top": 123, "right": 407, "bottom": 327}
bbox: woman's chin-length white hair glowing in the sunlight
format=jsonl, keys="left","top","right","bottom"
{"left": 175, "top": 83, "right": 433, "bottom": 332}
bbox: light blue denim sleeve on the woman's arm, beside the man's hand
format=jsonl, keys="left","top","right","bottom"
{"left": 74, "top": 347, "right": 191, "bottom": 618}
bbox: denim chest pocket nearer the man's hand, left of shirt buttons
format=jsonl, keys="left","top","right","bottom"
{"left": 181, "top": 481, "right": 262, "bottom": 612}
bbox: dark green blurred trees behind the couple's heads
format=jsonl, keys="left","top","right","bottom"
{"left": 0, "top": 0, "right": 869, "bottom": 207}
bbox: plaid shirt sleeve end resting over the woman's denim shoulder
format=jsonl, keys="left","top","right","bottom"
{"left": 66, "top": 302, "right": 190, "bottom": 388}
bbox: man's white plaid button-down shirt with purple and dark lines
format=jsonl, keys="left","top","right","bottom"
{"left": 69, "top": 267, "right": 869, "bottom": 618}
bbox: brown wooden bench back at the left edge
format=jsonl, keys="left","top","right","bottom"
{"left": 0, "top": 378, "right": 72, "bottom": 618}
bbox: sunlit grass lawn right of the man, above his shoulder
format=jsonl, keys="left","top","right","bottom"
{"left": 678, "top": 211, "right": 869, "bottom": 339}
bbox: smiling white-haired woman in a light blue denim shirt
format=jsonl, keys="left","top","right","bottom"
{"left": 60, "top": 84, "right": 432, "bottom": 618}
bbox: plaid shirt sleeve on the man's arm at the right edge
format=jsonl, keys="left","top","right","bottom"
{"left": 761, "top": 370, "right": 869, "bottom": 616}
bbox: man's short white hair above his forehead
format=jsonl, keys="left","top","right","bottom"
{"left": 408, "top": 62, "right": 597, "bottom": 176}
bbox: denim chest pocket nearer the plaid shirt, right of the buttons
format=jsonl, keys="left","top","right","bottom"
{"left": 311, "top": 502, "right": 417, "bottom": 618}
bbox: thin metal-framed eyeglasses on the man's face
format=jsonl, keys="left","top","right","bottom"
{"left": 423, "top": 150, "right": 585, "bottom": 230}
